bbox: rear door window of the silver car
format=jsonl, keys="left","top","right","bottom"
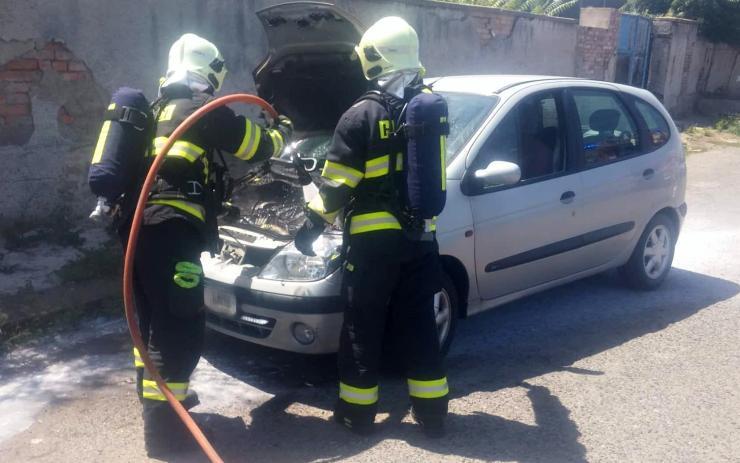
{"left": 572, "top": 89, "right": 640, "bottom": 167}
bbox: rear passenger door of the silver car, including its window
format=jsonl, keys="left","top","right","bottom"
{"left": 567, "top": 88, "right": 656, "bottom": 270}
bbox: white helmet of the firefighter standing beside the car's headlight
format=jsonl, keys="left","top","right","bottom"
{"left": 355, "top": 16, "right": 424, "bottom": 80}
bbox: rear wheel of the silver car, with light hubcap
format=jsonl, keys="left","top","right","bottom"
{"left": 619, "top": 214, "right": 678, "bottom": 291}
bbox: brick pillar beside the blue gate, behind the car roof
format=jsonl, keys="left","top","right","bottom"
{"left": 576, "top": 8, "right": 619, "bottom": 81}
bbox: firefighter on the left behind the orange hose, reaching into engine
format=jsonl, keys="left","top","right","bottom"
{"left": 127, "top": 34, "right": 292, "bottom": 457}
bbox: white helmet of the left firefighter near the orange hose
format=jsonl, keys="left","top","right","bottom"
{"left": 167, "top": 33, "right": 226, "bottom": 90}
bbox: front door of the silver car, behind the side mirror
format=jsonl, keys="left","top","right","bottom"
{"left": 463, "top": 89, "right": 580, "bottom": 299}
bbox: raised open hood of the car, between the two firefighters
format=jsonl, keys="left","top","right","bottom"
{"left": 253, "top": 2, "right": 367, "bottom": 133}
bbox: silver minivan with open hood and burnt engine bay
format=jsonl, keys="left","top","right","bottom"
{"left": 202, "top": 3, "right": 686, "bottom": 354}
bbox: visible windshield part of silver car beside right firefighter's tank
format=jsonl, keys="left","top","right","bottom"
{"left": 439, "top": 92, "right": 498, "bottom": 165}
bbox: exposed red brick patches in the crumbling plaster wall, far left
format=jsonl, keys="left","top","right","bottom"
{"left": 0, "top": 41, "right": 92, "bottom": 146}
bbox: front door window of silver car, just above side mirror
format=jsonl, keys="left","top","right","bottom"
{"left": 475, "top": 92, "right": 566, "bottom": 181}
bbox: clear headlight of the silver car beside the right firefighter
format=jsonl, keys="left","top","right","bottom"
{"left": 259, "top": 234, "right": 342, "bottom": 281}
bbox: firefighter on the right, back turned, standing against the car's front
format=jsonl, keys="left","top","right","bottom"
{"left": 296, "top": 17, "right": 448, "bottom": 437}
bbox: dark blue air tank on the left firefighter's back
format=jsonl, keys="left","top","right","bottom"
{"left": 88, "top": 87, "right": 154, "bottom": 220}
